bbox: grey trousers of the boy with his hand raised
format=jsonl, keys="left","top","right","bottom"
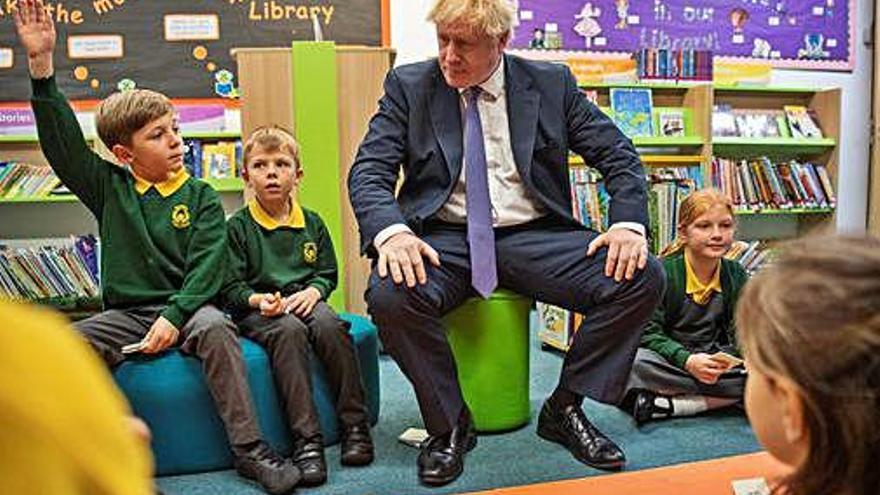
{"left": 74, "top": 304, "right": 262, "bottom": 452}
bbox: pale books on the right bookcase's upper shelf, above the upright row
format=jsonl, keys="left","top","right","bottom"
{"left": 712, "top": 104, "right": 822, "bottom": 139}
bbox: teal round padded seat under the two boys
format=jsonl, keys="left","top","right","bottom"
{"left": 113, "top": 313, "right": 379, "bottom": 476}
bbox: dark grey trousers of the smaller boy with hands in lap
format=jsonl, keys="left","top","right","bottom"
{"left": 236, "top": 301, "right": 368, "bottom": 446}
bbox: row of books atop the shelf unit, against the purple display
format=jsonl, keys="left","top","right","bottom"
{"left": 633, "top": 48, "right": 713, "bottom": 81}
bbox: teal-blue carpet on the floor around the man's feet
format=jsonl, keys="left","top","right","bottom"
{"left": 158, "top": 316, "right": 760, "bottom": 495}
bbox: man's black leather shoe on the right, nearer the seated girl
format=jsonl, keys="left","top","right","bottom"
{"left": 538, "top": 401, "right": 626, "bottom": 470}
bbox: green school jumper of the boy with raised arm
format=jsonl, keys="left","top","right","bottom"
{"left": 31, "top": 77, "right": 226, "bottom": 328}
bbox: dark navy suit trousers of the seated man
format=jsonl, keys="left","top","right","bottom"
{"left": 366, "top": 217, "right": 665, "bottom": 435}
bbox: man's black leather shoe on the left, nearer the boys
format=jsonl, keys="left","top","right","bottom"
{"left": 418, "top": 413, "right": 477, "bottom": 486}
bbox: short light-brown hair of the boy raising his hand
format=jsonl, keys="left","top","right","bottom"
{"left": 95, "top": 89, "right": 174, "bottom": 149}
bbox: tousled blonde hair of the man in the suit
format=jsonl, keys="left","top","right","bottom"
{"left": 428, "top": 0, "right": 516, "bottom": 38}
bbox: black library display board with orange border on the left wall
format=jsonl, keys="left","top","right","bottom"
{"left": 0, "top": 0, "right": 388, "bottom": 101}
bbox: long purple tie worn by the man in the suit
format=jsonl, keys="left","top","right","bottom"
{"left": 464, "top": 86, "right": 498, "bottom": 298}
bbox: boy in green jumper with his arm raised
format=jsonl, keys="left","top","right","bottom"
{"left": 15, "top": 0, "right": 301, "bottom": 494}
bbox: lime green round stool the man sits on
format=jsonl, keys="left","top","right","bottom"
{"left": 443, "top": 291, "right": 532, "bottom": 432}
